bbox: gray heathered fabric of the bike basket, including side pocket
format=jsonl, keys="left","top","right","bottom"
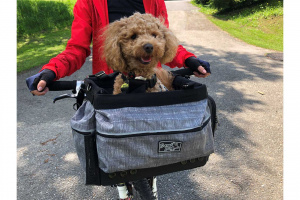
{"left": 71, "top": 97, "right": 214, "bottom": 173}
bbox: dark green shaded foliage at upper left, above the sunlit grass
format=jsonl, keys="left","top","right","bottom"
{"left": 17, "top": 0, "right": 73, "bottom": 37}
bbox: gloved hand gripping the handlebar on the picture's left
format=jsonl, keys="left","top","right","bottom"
{"left": 26, "top": 69, "right": 56, "bottom": 96}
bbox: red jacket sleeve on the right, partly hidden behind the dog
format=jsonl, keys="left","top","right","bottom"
{"left": 156, "top": 0, "right": 196, "bottom": 68}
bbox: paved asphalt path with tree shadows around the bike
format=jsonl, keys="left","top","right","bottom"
{"left": 17, "top": 1, "right": 283, "bottom": 200}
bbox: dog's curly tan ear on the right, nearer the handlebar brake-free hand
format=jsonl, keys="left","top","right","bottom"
{"left": 159, "top": 20, "right": 178, "bottom": 64}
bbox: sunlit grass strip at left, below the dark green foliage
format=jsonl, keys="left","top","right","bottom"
{"left": 17, "top": 28, "right": 71, "bottom": 72}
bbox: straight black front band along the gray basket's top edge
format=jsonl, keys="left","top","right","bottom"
{"left": 92, "top": 85, "right": 207, "bottom": 109}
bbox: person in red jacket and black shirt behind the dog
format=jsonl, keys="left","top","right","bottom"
{"left": 31, "top": 0, "right": 210, "bottom": 95}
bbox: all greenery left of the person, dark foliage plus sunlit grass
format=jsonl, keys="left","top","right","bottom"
{"left": 17, "top": 0, "right": 76, "bottom": 72}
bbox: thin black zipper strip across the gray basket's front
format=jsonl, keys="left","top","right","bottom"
{"left": 97, "top": 117, "right": 210, "bottom": 138}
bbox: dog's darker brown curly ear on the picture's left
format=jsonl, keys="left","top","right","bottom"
{"left": 102, "top": 21, "right": 126, "bottom": 72}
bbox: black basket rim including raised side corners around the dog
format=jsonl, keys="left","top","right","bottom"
{"left": 85, "top": 72, "right": 208, "bottom": 109}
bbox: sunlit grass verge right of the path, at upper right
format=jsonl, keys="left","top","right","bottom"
{"left": 192, "top": 1, "right": 283, "bottom": 51}
